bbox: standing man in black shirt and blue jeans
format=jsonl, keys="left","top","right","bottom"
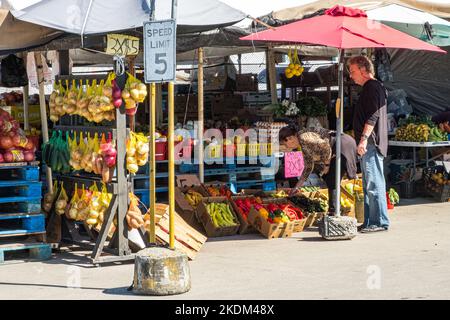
{"left": 348, "top": 56, "right": 389, "bottom": 232}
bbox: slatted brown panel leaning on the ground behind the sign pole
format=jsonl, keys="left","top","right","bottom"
{"left": 151, "top": 205, "right": 208, "bottom": 260}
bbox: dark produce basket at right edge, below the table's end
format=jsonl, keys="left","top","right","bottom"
{"left": 423, "top": 166, "right": 450, "bottom": 202}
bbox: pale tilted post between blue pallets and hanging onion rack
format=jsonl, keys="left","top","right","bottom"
{"left": 34, "top": 52, "right": 53, "bottom": 193}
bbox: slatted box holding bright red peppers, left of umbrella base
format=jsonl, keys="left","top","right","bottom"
{"left": 248, "top": 208, "right": 294, "bottom": 239}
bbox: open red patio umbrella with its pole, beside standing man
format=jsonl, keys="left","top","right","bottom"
{"left": 240, "top": 5, "right": 447, "bottom": 215}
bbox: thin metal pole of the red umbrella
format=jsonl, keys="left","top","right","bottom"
{"left": 334, "top": 49, "right": 344, "bottom": 216}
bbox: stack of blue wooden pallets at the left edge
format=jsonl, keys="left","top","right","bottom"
{"left": 0, "top": 162, "right": 51, "bottom": 264}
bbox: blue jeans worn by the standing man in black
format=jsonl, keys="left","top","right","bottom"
{"left": 361, "top": 144, "right": 389, "bottom": 228}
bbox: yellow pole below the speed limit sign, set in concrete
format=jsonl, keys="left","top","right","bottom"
{"left": 149, "top": 83, "right": 156, "bottom": 243}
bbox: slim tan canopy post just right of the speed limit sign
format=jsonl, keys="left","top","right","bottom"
{"left": 197, "top": 48, "right": 205, "bottom": 183}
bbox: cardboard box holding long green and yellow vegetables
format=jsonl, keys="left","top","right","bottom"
{"left": 197, "top": 197, "right": 240, "bottom": 237}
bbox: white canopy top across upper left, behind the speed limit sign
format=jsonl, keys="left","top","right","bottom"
{"left": 0, "top": 0, "right": 246, "bottom": 54}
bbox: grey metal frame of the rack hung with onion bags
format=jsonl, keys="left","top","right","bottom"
{"left": 46, "top": 74, "right": 135, "bottom": 264}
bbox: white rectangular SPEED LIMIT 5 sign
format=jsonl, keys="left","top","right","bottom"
{"left": 144, "top": 20, "right": 177, "bottom": 83}
